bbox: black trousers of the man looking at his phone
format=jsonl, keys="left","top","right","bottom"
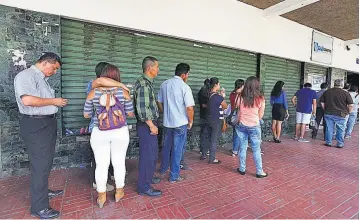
{"left": 20, "top": 117, "right": 57, "bottom": 213}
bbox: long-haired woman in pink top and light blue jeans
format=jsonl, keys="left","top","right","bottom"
{"left": 236, "top": 76, "right": 267, "bottom": 178}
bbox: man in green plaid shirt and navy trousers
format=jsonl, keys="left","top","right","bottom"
{"left": 134, "top": 56, "right": 161, "bottom": 196}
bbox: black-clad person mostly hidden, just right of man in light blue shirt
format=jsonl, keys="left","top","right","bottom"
{"left": 198, "top": 79, "right": 210, "bottom": 154}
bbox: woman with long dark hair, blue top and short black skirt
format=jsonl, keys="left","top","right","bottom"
{"left": 270, "top": 81, "right": 289, "bottom": 143}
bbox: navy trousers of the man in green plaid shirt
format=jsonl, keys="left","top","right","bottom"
{"left": 136, "top": 121, "right": 159, "bottom": 193}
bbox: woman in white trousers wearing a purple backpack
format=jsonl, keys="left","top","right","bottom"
{"left": 84, "top": 64, "right": 134, "bottom": 208}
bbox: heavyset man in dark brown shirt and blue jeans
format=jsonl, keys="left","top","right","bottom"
{"left": 320, "top": 79, "right": 353, "bottom": 148}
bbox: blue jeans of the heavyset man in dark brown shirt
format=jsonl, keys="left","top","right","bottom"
{"left": 325, "top": 115, "right": 346, "bottom": 147}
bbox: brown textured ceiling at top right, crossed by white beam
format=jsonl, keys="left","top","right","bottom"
{"left": 239, "top": 0, "right": 359, "bottom": 40}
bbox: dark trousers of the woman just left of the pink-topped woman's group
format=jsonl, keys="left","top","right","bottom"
{"left": 202, "top": 119, "right": 223, "bottom": 162}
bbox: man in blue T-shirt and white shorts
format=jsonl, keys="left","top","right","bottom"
{"left": 291, "top": 83, "right": 316, "bottom": 142}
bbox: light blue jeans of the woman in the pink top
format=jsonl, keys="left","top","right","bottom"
{"left": 236, "top": 123, "right": 264, "bottom": 175}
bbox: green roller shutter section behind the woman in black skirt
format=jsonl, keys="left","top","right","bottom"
{"left": 260, "top": 55, "right": 301, "bottom": 131}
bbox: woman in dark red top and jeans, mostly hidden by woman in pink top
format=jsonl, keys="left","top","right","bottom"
{"left": 230, "top": 79, "right": 245, "bottom": 157}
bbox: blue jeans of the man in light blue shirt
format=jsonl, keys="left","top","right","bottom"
{"left": 160, "top": 125, "right": 187, "bottom": 181}
